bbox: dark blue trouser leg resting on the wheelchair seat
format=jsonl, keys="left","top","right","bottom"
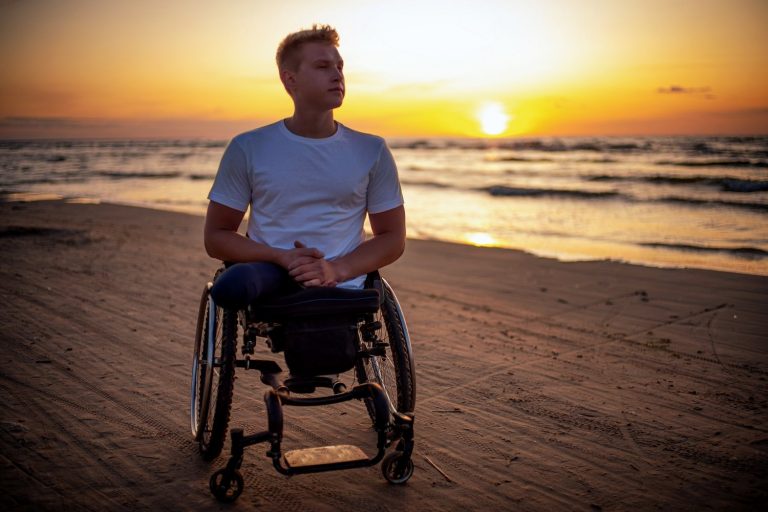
{"left": 211, "top": 262, "right": 300, "bottom": 309}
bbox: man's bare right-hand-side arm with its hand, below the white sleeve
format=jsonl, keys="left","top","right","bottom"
{"left": 286, "top": 206, "right": 405, "bottom": 286}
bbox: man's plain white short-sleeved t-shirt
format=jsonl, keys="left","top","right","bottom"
{"left": 208, "top": 121, "right": 403, "bottom": 288}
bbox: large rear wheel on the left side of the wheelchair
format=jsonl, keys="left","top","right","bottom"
{"left": 190, "top": 288, "right": 237, "bottom": 460}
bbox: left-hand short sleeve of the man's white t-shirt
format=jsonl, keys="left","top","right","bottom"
{"left": 208, "top": 139, "right": 251, "bottom": 212}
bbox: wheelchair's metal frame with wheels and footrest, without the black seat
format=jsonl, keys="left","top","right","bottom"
{"left": 190, "top": 268, "right": 416, "bottom": 502}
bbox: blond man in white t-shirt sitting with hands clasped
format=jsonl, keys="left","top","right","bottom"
{"left": 205, "top": 25, "right": 405, "bottom": 308}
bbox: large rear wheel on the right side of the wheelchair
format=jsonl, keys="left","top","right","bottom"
{"left": 355, "top": 278, "right": 416, "bottom": 421}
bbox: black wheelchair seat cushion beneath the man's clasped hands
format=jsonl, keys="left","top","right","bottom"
{"left": 251, "top": 287, "right": 379, "bottom": 322}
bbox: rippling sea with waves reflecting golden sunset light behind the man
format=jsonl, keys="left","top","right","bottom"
{"left": 0, "top": 136, "right": 768, "bottom": 275}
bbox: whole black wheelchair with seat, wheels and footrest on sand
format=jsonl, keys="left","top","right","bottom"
{"left": 190, "top": 267, "right": 416, "bottom": 502}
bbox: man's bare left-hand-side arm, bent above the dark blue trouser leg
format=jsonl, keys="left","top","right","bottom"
{"left": 204, "top": 201, "right": 323, "bottom": 269}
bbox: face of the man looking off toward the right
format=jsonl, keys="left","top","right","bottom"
{"left": 286, "top": 43, "right": 346, "bottom": 110}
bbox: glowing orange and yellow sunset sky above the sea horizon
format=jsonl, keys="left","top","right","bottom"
{"left": 0, "top": 0, "right": 768, "bottom": 139}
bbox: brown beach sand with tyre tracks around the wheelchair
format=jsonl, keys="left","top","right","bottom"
{"left": 0, "top": 201, "right": 768, "bottom": 512}
